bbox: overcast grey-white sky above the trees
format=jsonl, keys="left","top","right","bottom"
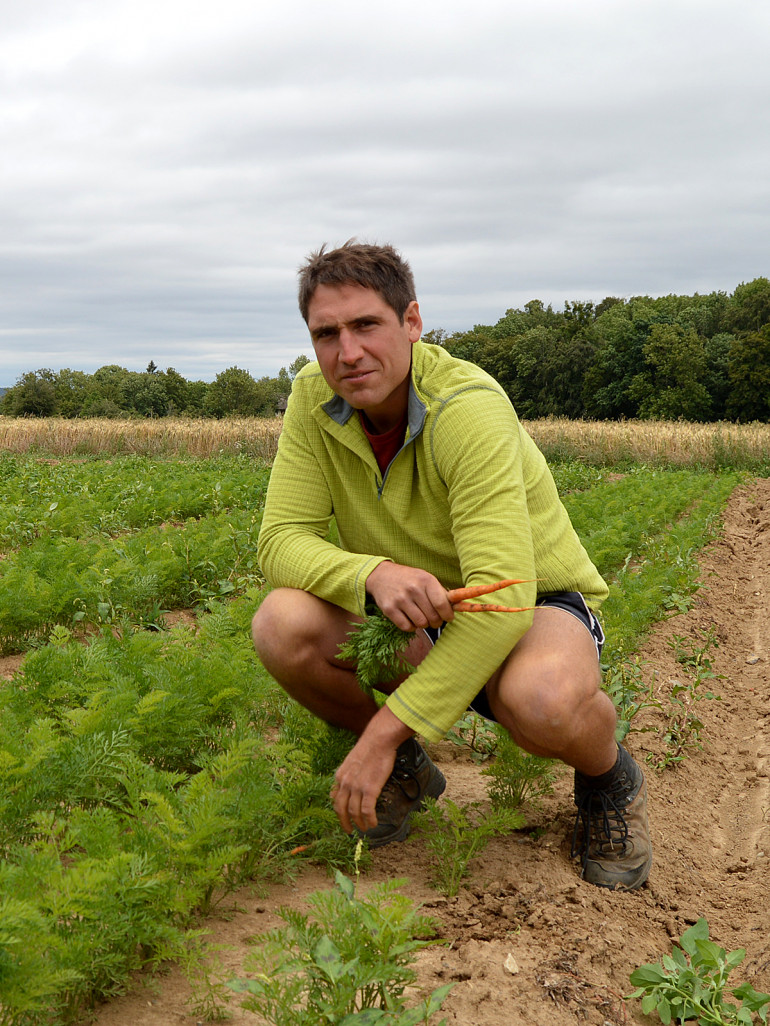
{"left": 0, "top": 0, "right": 770, "bottom": 386}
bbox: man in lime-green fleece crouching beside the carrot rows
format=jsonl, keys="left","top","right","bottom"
{"left": 254, "top": 242, "right": 652, "bottom": 890}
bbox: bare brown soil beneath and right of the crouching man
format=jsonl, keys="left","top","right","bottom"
{"left": 19, "top": 479, "right": 770, "bottom": 1026}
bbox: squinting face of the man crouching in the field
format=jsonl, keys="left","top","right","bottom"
{"left": 308, "top": 285, "right": 422, "bottom": 432}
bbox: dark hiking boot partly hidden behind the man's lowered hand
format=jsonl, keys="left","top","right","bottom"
{"left": 363, "top": 738, "right": 447, "bottom": 847}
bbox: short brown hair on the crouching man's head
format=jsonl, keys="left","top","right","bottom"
{"left": 299, "top": 239, "right": 417, "bottom": 324}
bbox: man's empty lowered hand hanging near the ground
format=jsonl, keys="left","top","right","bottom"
{"left": 332, "top": 706, "right": 415, "bottom": 833}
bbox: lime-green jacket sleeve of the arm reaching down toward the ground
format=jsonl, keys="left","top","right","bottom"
{"left": 387, "top": 389, "right": 542, "bottom": 741}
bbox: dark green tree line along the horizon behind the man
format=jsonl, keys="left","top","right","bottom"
{"left": 0, "top": 278, "right": 770, "bottom": 423}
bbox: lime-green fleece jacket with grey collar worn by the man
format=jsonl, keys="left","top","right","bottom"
{"left": 259, "top": 342, "right": 607, "bottom": 741}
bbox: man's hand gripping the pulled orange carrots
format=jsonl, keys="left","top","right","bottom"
{"left": 367, "top": 560, "right": 455, "bottom": 631}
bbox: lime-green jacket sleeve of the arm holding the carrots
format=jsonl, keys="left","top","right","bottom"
{"left": 259, "top": 379, "right": 384, "bottom": 616}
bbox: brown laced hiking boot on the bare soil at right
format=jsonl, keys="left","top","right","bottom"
{"left": 571, "top": 745, "right": 652, "bottom": 891}
